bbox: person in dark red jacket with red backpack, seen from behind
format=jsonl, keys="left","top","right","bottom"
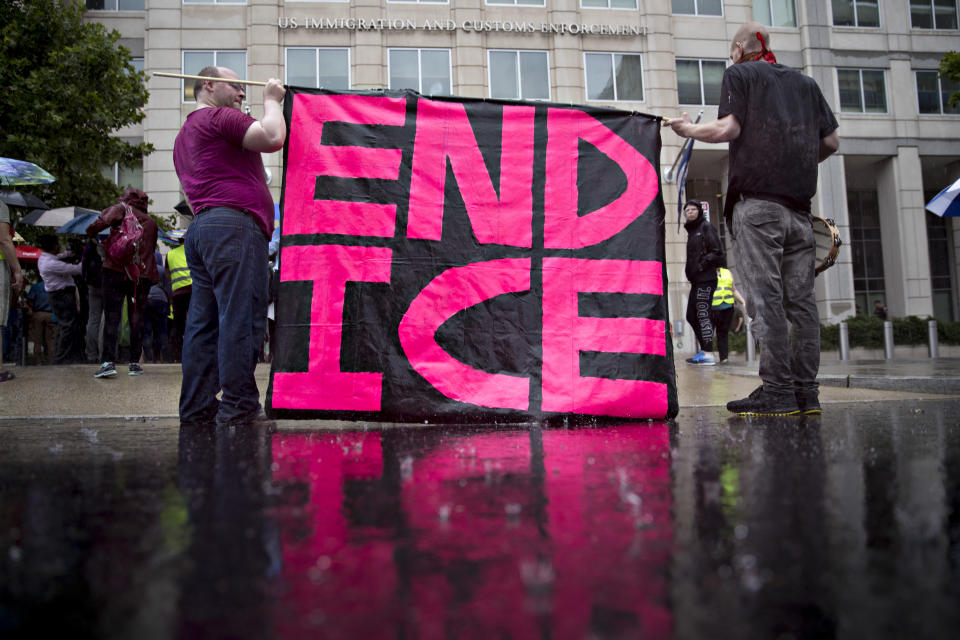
{"left": 87, "top": 187, "right": 159, "bottom": 378}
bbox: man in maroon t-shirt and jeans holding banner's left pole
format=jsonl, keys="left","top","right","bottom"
{"left": 173, "top": 67, "right": 287, "bottom": 425}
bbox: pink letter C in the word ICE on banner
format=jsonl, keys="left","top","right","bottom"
{"left": 399, "top": 258, "right": 530, "bottom": 411}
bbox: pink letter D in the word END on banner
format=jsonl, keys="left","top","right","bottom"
{"left": 543, "top": 108, "right": 660, "bottom": 249}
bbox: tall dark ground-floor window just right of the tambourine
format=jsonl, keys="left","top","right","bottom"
{"left": 847, "top": 190, "right": 887, "bottom": 314}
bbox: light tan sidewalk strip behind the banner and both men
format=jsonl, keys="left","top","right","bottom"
{"left": 0, "top": 358, "right": 960, "bottom": 424}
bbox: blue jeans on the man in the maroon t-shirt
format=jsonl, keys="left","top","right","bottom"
{"left": 180, "top": 207, "right": 269, "bottom": 424}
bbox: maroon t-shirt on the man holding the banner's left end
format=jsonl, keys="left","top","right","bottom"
{"left": 173, "top": 107, "right": 273, "bottom": 238}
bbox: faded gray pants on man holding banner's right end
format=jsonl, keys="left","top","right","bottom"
{"left": 733, "top": 198, "right": 820, "bottom": 394}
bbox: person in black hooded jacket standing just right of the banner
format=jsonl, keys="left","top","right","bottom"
{"left": 683, "top": 200, "right": 724, "bottom": 365}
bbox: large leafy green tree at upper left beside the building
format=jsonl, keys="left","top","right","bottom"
{"left": 0, "top": 0, "right": 153, "bottom": 218}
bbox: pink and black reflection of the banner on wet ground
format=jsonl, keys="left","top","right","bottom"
{"left": 273, "top": 423, "right": 673, "bottom": 638}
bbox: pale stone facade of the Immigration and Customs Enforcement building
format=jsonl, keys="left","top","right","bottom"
{"left": 87, "top": 0, "right": 960, "bottom": 348}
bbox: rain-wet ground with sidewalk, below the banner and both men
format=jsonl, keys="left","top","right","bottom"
{"left": 0, "top": 363, "right": 960, "bottom": 639}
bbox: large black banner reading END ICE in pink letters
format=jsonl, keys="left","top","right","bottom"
{"left": 267, "top": 87, "right": 678, "bottom": 422}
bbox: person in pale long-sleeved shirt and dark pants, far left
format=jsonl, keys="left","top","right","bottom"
{"left": 37, "top": 235, "right": 82, "bottom": 364}
